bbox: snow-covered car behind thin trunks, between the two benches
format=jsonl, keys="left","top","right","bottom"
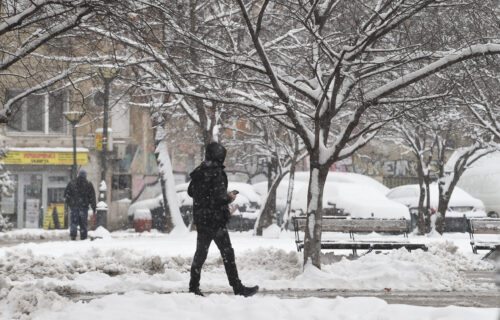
{"left": 387, "top": 183, "right": 486, "bottom": 218}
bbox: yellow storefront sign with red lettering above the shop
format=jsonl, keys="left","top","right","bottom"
{"left": 0, "top": 151, "right": 88, "bottom": 165}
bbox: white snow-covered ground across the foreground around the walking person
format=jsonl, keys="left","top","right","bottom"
{"left": 0, "top": 229, "right": 496, "bottom": 319}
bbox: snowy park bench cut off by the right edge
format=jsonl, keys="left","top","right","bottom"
{"left": 467, "top": 218, "right": 500, "bottom": 259}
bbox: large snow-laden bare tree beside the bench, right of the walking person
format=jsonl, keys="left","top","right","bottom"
{"left": 157, "top": 0, "right": 500, "bottom": 267}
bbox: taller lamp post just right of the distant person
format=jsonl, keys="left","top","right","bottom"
{"left": 95, "top": 67, "right": 117, "bottom": 228}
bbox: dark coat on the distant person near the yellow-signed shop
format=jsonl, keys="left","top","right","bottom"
{"left": 64, "top": 177, "right": 96, "bottom": 212}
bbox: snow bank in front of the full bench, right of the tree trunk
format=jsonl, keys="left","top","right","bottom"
{"left": 293, "top": 241, "right": 494, "bottom": 291}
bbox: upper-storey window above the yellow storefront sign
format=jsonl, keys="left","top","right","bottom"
{"left": 6, "top": 89, "right": 68, "bottom": 134}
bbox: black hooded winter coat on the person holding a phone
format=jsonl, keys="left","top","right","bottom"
{"left": 188, "top": 142, "right": 233, "bottom": 229}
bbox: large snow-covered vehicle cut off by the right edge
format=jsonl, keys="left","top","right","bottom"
{"left": 457, "top": 152, "right": 500, "bottom": 218}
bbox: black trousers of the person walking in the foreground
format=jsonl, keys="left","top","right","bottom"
{"left": 189, "top": 227, "right": 241, "bottom": 290}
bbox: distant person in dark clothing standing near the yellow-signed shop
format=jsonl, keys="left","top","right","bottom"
{"left": 64, "top": 170, "right": 96, "bottom": 240}
